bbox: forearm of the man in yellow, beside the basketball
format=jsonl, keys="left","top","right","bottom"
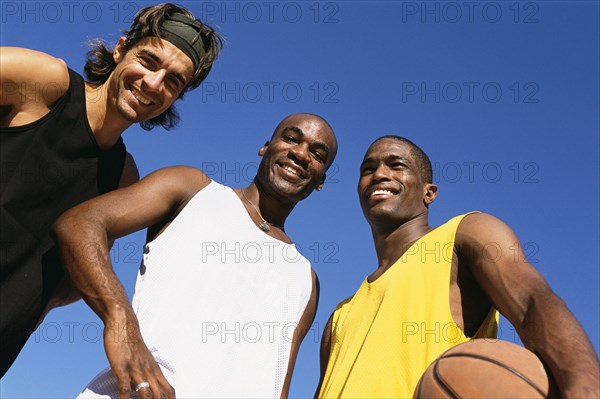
{"left": 516, "top": 292, "right": 600, "bottom": 399}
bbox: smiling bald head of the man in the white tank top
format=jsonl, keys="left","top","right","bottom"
{"left": 256, "top": 114, "right": 337, "bottom": 204}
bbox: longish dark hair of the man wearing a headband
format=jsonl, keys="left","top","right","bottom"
{"left": 83, "top": 3, "right": 223, "bottom": 130}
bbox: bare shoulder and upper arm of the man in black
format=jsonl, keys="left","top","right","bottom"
{"left": 0, "top": 47, "right": 69, "bottom": 126}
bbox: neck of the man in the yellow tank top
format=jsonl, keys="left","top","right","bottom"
{"left": 371, "top": 212, "right": 433, "bottom": 270}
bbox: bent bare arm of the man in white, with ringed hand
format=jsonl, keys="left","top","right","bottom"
{"left": 52, "top": 167, "right": 209, "bottom": 398}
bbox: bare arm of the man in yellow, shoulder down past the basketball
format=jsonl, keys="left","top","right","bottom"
{"left": 456, "top": 214, "right": 600, "bottom": 398}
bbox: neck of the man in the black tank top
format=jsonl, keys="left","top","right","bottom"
{"left": 85, "top": 83, "right": 131, "bottom": 149}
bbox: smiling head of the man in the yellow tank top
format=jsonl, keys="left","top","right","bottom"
{"left": 358, "top": 138, "right": 437, "bottom": 228}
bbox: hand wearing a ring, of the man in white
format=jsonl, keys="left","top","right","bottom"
{"left": 104, "top": 315, "right": 175, "bottom": 399}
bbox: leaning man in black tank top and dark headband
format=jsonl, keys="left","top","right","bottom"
{"left": 0, "top": 3, "right": 221, "bottom": 377}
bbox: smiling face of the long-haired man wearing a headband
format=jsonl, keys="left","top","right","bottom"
{"left": 107, "top": 37, "right": 194, "bottom": 123}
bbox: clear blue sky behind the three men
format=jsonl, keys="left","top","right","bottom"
{"left": 0, "top": 0, "right": 600, "bottom": 398}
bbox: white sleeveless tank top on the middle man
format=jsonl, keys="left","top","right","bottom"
{"left": 81, "top": 182, "right": 312, "bottom": 398}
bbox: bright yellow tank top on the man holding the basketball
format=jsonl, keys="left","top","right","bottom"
{"left": 318, "top": 215, "right": 498, "bottom": 398}
